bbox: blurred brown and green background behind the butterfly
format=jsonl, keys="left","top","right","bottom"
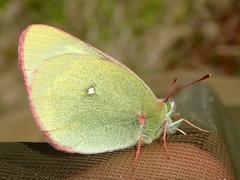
{"left": 0, "top": 0, "right": 240, "bottom": 141}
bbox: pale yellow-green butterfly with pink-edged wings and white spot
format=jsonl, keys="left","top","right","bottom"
{"left": 18, "top": 25, "right": 209, "bottom": 167}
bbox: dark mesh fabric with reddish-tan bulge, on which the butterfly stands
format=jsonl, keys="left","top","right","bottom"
{"left": 0, "top": 85, "right": 238, "bottom": 179}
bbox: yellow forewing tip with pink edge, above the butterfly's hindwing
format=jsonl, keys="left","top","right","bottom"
{"left": 18, "top": 24, "right": 114, "bottom": 88}
